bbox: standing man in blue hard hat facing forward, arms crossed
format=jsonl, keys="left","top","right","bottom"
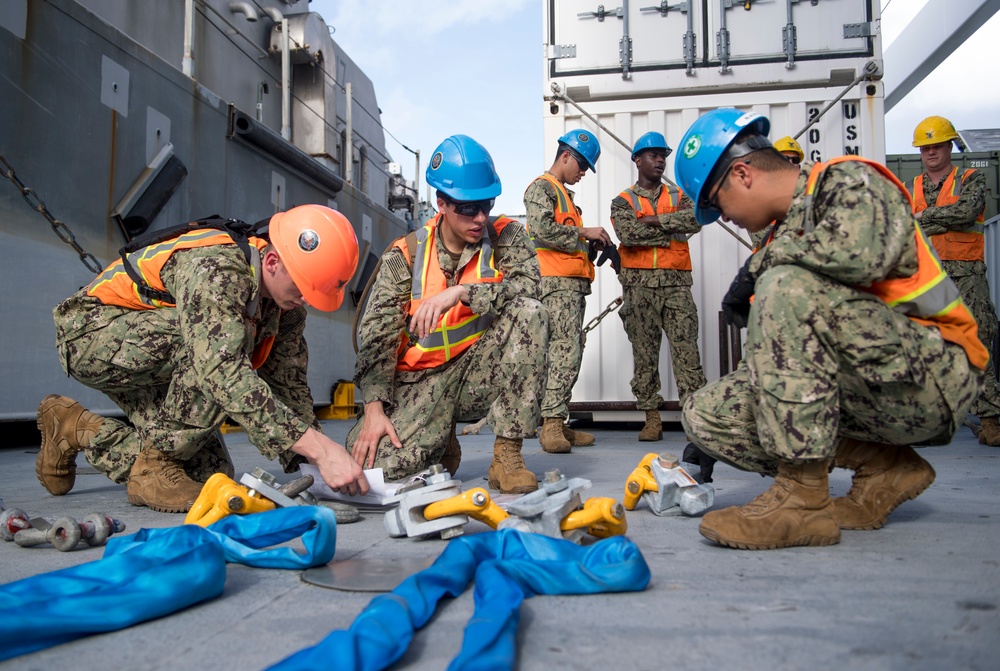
{"left": 611, "top": 131, "right": 705, "bottom": 441}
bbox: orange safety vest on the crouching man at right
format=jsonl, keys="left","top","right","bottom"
{"left": 805, "top": 156, "right": 989, "bottom": 370}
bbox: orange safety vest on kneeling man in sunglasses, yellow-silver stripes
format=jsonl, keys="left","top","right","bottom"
{"left": 392, "top": 214, "right": 514, "bottom": 371}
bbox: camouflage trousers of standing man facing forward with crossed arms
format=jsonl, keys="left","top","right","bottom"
{"left": 619, "top": 285, "right": 705, "bottom": 410}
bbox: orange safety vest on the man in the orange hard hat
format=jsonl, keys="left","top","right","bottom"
{"left": 87, "top": 228, "right": 274, "bottom": 370}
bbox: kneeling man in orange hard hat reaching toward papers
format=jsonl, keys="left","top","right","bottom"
{"left": 36, "top": 205, "right": 367, "bottom": 512}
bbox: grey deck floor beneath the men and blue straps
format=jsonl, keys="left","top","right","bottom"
{"left": 0, "top": 421, "right": 1000, "bottom": 671}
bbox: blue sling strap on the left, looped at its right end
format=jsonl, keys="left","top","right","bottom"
{"left": 0, "top": 506, "right": 337, "bottom": 660}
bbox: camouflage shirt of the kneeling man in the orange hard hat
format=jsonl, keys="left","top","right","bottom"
{"left": 54, "top": 245, "right": 319, "bottom": 467}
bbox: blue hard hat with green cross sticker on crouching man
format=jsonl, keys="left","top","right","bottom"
{"left": 674, "top": 107, "right": 771, "bottom": 226}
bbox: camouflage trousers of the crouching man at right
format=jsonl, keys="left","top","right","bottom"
{"left": 682, "top": 266, "right": 982, "bottom": 475}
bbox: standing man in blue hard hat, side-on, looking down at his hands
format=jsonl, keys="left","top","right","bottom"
{"left": 524, "top": 130, "right": 613, "bottom": 453}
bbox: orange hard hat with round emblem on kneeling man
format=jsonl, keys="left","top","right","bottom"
{"left": 268, "top": 205, "right": 358, "bottom": 312}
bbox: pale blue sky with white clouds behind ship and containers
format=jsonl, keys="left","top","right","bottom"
{"left": 310, "top": 0, "right": 1000, "bottom": 214}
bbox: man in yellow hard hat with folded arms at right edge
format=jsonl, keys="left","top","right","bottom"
{"left": 906, "top": 116, "right": 1000, "bottom": 446}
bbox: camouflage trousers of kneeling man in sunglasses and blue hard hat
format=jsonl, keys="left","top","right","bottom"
{"left": 345, "top": 297, "right": 549, "bottom": 480}
